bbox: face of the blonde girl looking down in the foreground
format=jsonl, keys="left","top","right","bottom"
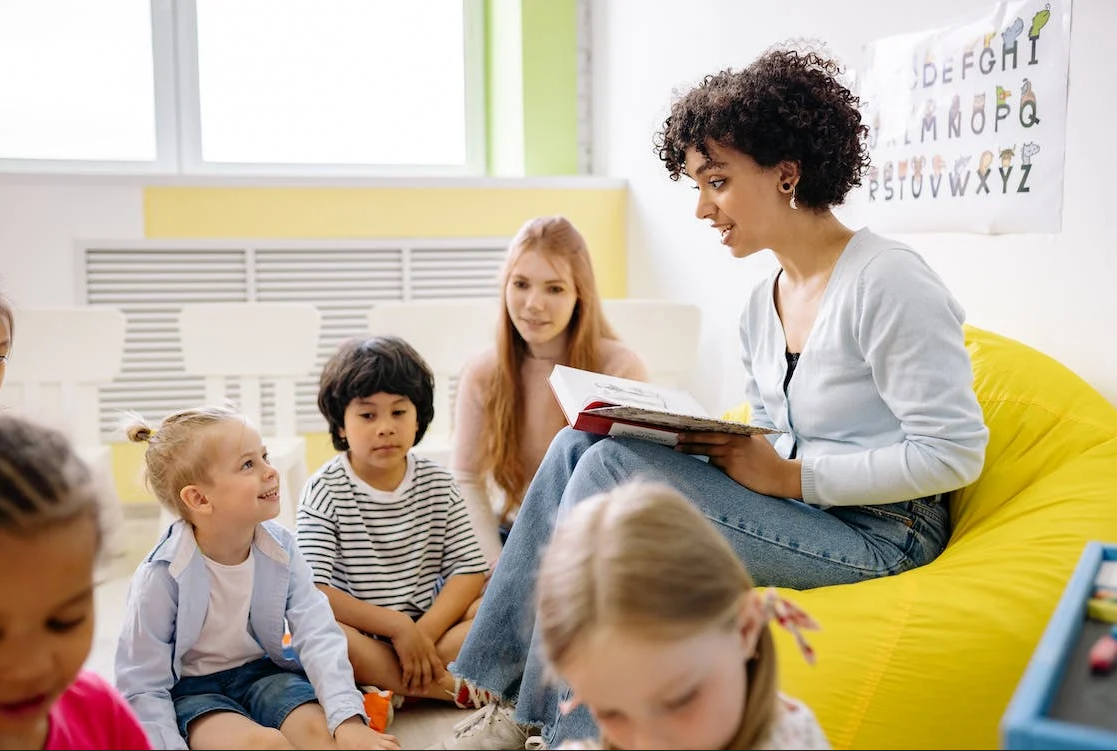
{"left": 559, "top": 610, "right": 756, "bottom": 749}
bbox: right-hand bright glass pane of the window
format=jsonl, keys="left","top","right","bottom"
{"left": 188, "top": 0, "right": 467, "bottom": 168}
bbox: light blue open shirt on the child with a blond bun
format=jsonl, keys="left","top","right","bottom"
{"left": 116, "top": 520, "right": 367, "bottom": 749}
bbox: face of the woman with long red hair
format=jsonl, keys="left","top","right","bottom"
{"left": 504, "top": 250, "right": 577, "bottom": 358}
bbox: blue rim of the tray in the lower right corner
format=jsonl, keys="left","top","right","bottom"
{"left": 1001, "top": 542, "right": 1117, "bottom": 749}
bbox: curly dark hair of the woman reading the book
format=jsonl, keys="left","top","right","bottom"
{"left": 655, "top": 47, "right": 869, "bottom": 209}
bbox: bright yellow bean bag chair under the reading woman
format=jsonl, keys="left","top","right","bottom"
{"left": 750, "top": 326, "right": 1117, "bottom": 749}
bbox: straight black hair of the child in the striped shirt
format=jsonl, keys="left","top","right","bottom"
{"left": 318, "top": 336, "right": 435, "bottom": 451}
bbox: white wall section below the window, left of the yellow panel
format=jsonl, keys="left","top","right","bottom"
{"left": 0, "top": 182, "right": 143, "bottom": 308}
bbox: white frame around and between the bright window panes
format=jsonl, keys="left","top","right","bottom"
{"left": 0, "top": 0, "right": 487, "bottom": 178}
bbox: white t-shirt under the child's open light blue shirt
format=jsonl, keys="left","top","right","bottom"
{"left": 182, "top": 552, "right": 265, "bottom": 677}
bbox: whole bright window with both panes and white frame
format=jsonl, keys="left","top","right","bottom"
{"left": 0, "top": 0, "right": 485, "bottom": 177}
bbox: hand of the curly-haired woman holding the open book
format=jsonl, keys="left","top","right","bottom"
{"left": 675, "top": 432, "right": 803, "bottom": 498}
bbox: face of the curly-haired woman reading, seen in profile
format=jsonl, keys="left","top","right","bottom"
{"left": 686, "top": 143, "right": 792, "bottom": 258}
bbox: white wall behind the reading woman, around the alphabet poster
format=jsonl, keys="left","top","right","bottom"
{"left": 593, "top": 0, "right": 1117, "bottom": 411}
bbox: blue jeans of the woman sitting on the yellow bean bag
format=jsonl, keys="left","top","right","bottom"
{"left": 450, "top": 428, "right": 949, "bottom": 748}
